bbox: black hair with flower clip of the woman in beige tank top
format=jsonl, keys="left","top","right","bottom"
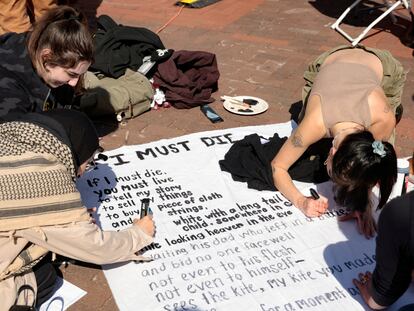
{"left": 331, "top": 131, "right": 397, "bottom": 212}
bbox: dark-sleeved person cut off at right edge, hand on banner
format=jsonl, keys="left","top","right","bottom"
{"left": 353, "top": 191, "right": 414, "bottom": 311}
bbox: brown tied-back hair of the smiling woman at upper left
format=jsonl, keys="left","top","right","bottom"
{"left": 27, "top": 5, "right": 94, "bottom": 69}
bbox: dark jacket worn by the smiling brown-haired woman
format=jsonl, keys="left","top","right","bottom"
{"left": 0, "top": 33, "right": 73, "bottom": 120}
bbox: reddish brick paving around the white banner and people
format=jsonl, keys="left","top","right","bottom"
{"left": 62, "top": 0, "right": 414, "bottom": 310}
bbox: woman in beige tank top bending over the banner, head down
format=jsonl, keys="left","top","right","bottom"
{"left": 271, "top": 46, "right": 406, "bottom": 237}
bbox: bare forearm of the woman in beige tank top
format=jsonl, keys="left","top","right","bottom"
{"left": 272, "top": 163, "right": 306, "bottom": 210}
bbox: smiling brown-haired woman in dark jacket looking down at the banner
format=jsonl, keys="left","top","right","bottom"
{"left": 0, "top": 6, "right": 94, "bottom": 120}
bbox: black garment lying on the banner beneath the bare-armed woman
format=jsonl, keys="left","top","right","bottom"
{"left": 219, "top": 133, "right": 330, "bottom": 191}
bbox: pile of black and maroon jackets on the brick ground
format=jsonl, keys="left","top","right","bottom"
{"left": 90, "top": 15, "right": 220, "bottom": 108}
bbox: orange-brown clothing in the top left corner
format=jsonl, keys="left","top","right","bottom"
{"left": 0, "top": 0, "right": 57, "bottom": 34}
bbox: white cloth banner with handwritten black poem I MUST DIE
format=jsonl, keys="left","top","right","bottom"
{"left": 78, "top": 123, "right": 414, "bottom": 311}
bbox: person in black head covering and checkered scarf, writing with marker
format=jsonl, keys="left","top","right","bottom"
{"left": 0, "top": 109, "right": 155, "bottom": 310}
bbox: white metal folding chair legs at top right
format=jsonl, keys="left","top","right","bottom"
{"left": 331, "top": 0, "right": 411, "bottom": 46}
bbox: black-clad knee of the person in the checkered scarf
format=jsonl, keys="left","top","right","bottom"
{"left": 33, "top": 260, "right": 57, "bottom": 307}
